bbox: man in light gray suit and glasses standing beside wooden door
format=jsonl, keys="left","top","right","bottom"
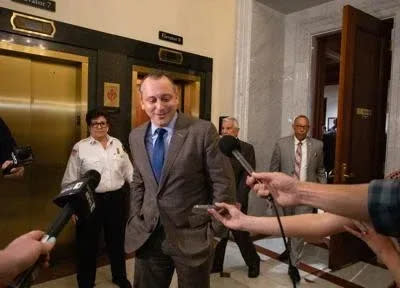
{"left": 270, "top": 115, "right": 326, "bottom": 264}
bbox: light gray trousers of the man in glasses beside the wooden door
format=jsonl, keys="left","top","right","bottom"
{"left": 283, "top": 205, "right": 313, "bottom": 265}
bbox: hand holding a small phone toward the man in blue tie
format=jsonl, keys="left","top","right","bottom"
{"left": 208, "top": 203, "right": 246, "bottom": 230}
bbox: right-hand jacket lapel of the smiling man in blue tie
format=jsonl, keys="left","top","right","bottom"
{"left": 157, "top": 114, "right": 188, "bottom": 193}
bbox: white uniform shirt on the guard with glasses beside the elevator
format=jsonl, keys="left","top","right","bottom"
{"left": 61, "top": 135, "right": 133, "bottom": 193}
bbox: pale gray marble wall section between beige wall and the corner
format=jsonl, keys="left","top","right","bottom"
{"left": 235, "top": 0, "right": 284, "bottom": 215}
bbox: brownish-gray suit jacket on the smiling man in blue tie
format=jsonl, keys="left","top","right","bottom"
{"left": 125, "top": 114, "right": 235, "bottom": 266}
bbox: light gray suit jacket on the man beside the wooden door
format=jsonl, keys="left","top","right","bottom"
{"left": 269, "top": 135, "right": 326, "bottom": 183}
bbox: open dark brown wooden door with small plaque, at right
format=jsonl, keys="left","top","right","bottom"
{"left": 329, "top": 5, "right": 392, "bottom": 269}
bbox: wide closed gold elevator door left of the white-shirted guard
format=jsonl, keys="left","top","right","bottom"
{"left": 0, "top": 50, "right": 81, "bottom": 258}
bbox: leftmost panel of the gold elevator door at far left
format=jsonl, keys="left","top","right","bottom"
{"left": 0, "top": 54, "right": 31, "bottom": 247}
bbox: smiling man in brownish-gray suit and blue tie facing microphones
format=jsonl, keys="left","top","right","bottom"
{"left": 125, "top": 74, "right": 235, "bottom": 288}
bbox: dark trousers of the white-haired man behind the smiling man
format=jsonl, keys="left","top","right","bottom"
{"left": 212, "top": 230, "right": 260, "bottom": 272}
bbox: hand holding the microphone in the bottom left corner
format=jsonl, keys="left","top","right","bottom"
{"left": 0, "top": 231, "right": 55, "bottom": 282}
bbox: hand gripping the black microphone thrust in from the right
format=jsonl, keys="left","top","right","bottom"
{"left": 246, "top": 172, "right": 300, "bottom": 206}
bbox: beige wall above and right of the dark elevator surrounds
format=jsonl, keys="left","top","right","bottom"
{"left": 0, "top": 0, "right": 236, "bottom": 125}
